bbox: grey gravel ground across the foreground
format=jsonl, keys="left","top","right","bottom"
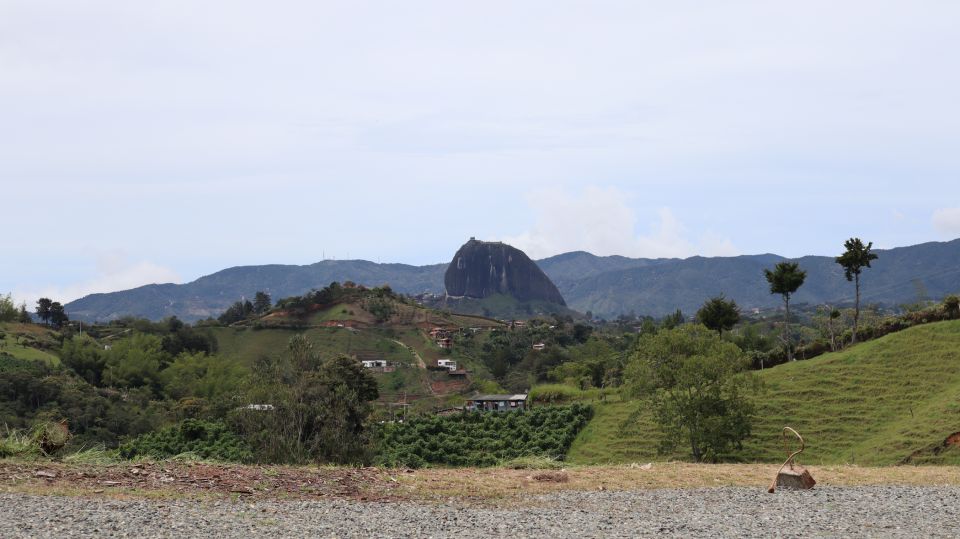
{"left": 0, "top": 487, "right": 960, "bottom": 539}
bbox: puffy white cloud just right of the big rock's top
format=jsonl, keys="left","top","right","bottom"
{"left": 503, "top": 186, "right": 738, "bottom": 258}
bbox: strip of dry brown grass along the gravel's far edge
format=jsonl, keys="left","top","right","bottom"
{"left": 0, "top": 461, "right": 960, "bottom": 504}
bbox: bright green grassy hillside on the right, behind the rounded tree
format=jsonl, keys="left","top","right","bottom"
{"left": 569, "top": 321, "right": 960, "bottom": 465}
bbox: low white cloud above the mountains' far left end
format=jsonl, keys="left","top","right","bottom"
{"left": 13, "top": 251, "right": 180, "bottom": 308}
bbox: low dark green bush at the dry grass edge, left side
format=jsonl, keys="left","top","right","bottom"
{"left": 119, "top": 419, "right": 253, "bottom": 462}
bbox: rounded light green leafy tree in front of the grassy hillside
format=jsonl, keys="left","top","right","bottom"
{"left": 624, "top": 325, "right": 756, "bottom": 462}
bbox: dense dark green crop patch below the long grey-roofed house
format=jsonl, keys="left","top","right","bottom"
{"left": 377, "top": 404, "right": 593, "bottom": 468}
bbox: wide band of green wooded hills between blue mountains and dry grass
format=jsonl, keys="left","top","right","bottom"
{"left": 0, "top": 276, "right": 960, "bottom": 468}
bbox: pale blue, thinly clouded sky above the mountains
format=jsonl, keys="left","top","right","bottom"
{"left": 0, "top": 0, "right": 960, "bottom": 304}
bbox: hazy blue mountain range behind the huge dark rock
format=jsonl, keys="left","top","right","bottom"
{"left": 66, "top": 239, "right": 960, "bottom": 321}
